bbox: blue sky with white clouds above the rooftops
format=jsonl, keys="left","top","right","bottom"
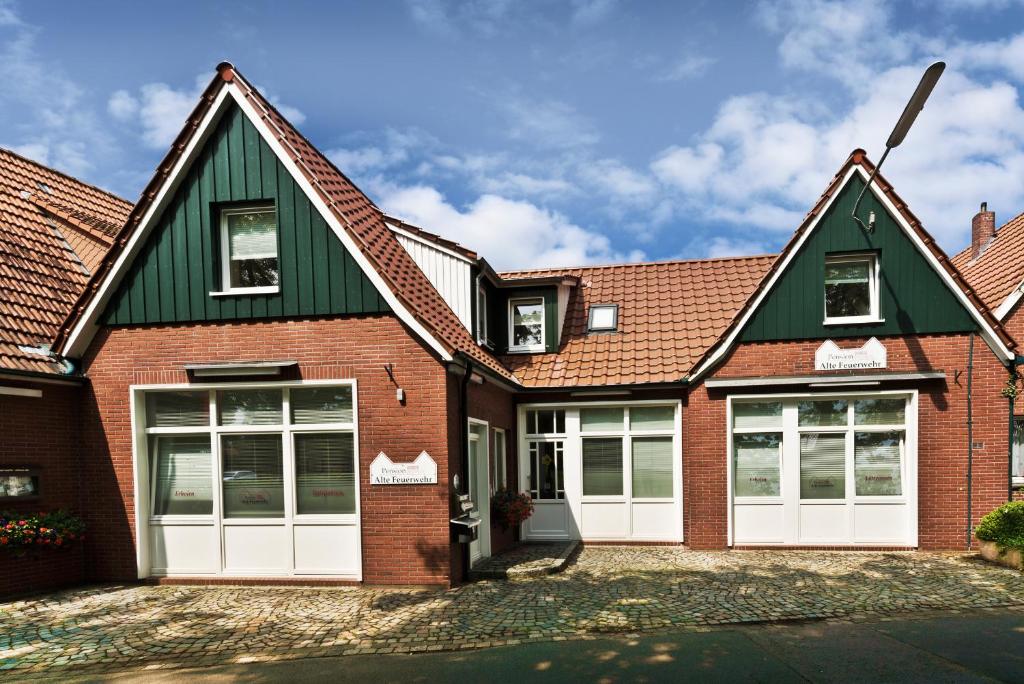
{"left": 0, "top": 0, "right": 1024, "bottom": 269}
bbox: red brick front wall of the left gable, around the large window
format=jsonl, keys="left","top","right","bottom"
{"left": 83, "top": 314, "right": 458, "bottom": 584}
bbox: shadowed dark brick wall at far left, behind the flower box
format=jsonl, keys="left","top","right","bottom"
{"left": 0, "top": 380, "right": 83, "bottom": 596}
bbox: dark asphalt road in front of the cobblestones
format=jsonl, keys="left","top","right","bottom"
{"left": 59, "top": 608, "right": 1024, "bottom": 684}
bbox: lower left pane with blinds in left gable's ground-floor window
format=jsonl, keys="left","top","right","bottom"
{"left": 150, "top": 434, "right": 213, "bottom": 515}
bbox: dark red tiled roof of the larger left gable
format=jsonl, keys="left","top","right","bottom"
{"left": 56, "top": 62, "right": 514, "bottom": 380}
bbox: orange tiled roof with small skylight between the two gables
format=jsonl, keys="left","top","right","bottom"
{"left": 501, "top": 256, "right": 775, "bottom": 387}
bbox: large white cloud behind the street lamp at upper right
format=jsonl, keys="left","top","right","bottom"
{"left": 651, "top": 0, "right": 1024, "bottom": 251}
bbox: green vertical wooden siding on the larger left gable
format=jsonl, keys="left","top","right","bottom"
{"left": 103, "top": 104, "right": 389, "bottom": 326}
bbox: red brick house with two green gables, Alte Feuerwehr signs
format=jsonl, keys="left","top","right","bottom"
{"left": 4, "top": 63, "right": 1016, "bottom": 586}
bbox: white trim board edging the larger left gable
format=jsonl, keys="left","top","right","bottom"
{"left": 59, "top": 75, "right": 452, "bottom": 361}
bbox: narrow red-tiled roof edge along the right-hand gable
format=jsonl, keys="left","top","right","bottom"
{"left": 691, "top": 148, "right": 1017, "bottom": 380}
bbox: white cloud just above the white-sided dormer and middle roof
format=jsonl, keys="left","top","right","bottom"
{"left": 378, "top": 185, "right": 643, "bottom": 269}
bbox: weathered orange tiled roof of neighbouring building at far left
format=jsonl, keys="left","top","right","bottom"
{"left": 0, "top": 148, "right": 131, "bottom": 373}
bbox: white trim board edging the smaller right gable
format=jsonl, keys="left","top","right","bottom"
{"left": 687, "top": 165, "right": 1014, "bottom": 382}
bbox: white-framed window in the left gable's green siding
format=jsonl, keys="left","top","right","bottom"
{"left": 213, "top": 204, "right": 280, "bottom": 294}
